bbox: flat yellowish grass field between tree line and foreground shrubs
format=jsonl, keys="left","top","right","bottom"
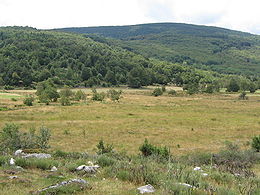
{"left": 0, "top": 88, "right": 260, "bottom": 154}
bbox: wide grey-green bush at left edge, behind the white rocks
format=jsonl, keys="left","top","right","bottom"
{"left": 0, "top": 123, "right": 50, "bottom": 152}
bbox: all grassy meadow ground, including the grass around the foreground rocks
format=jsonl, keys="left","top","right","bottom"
{"left": 0, "top": 87, "right": 260, "bottom": 195}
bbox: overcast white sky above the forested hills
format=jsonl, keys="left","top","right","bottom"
{"left": 0, "top": 0, "right": 260, "bottom": 34}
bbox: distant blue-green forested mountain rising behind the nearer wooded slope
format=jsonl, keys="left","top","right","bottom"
{"left": 56, "top": 23, "right": 260, "bottom": 76}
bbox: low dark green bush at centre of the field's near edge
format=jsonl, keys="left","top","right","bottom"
{"left": 139, "top": 139, "right": 170, "bottom": 159}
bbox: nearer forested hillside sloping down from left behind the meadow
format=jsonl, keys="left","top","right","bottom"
{"left": 0, "top": 27, "right": 224, "bottom": 88}
